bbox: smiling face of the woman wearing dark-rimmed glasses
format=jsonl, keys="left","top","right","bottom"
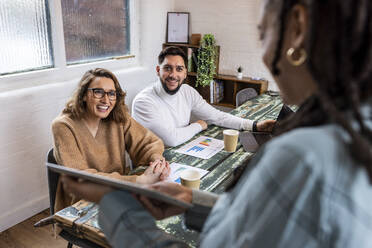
{"left": 84, "top": 77, "right": 116, "bottom": 120}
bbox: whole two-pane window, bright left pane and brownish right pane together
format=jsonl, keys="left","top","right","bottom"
{"left": 0, "top": 0, "right": 131, "bottom": 75}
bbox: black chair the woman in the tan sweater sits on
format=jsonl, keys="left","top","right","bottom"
{"left": 47, "top": 148, "right": 102, "bottom": 248}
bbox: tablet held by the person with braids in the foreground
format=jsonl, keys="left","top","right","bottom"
{"left": 47, "top": 163, "right": 193, "bottom": 209}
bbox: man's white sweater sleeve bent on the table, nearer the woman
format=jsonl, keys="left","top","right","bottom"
{"left": 132, "top": 100, "right": 202, "bottom": 146}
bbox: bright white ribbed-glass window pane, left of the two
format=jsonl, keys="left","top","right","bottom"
{"left": 0, "top": 0, "right": 53, "bottom": 75}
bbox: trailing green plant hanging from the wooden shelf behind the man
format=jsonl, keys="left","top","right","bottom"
{"left": 196, "top": 34, "right": 217, "bottom": 86}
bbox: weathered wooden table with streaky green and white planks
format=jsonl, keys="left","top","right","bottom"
{"left": 55, "top": 94, "right": 282, "bottom": 247}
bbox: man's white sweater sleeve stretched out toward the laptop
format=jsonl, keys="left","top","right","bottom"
{"left": 189, "top": 87, "right": 253, "bottom": 131}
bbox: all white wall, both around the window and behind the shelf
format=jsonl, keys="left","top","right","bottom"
{"left": 0, "top": 0, "right": 273, "bottom": 232}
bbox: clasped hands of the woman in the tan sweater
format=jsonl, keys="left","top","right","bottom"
{"left": 136, "top": 159, "right": 170, "bottom": 184}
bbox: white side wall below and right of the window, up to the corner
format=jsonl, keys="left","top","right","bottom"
{"left": 0, "top": 0, "right": 174, "bottom": 232}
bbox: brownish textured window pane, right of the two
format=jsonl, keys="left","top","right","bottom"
{"left": 62, "top": 0, "right": 129, "bottom": 64}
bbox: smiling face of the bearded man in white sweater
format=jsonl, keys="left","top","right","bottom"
{"left": 156, "top": 55, "right": 187, "bottom": 94}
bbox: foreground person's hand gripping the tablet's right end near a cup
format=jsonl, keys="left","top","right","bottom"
{"left": 136, "top": 182, "right": 192, "bottom": 220}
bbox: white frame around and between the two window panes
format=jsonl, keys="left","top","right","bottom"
{"left": 0, "top": 0, "right": 140, "bottom": 92}
